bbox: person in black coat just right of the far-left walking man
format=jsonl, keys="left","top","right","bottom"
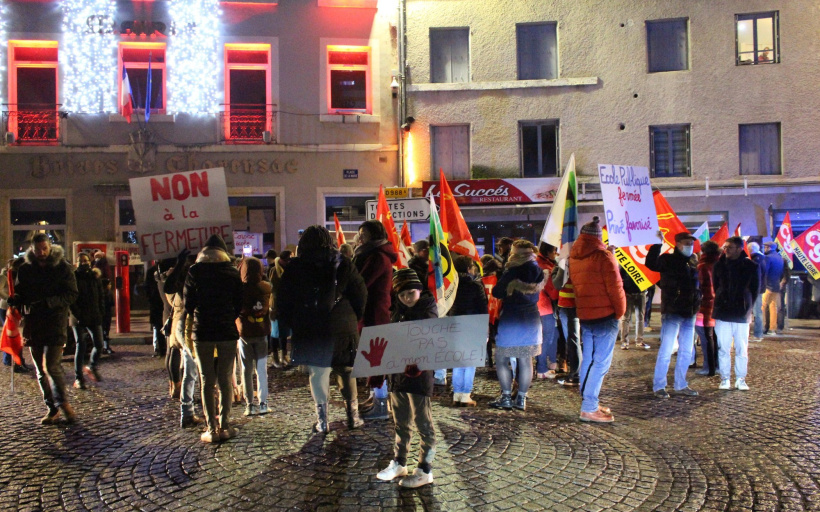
{"left": 71, "top": 253, "right": 105, "bottom": 389}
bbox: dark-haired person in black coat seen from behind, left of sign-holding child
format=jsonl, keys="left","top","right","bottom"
{"left": 277, "top": 225, "right": 367, "bottom": 433}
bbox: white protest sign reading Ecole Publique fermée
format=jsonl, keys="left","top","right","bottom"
{"left": 598, "top": 164, "right": 660, "bottom": 247}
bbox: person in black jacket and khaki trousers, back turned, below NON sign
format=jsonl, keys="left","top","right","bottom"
{"left": 183, "top": 235, "right": 243, "bottom": 443}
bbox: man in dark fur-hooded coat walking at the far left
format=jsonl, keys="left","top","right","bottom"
{"left": 8, "top": 233, "right": 79, "bottom": 425}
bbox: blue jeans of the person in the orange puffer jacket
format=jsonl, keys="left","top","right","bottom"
{"left": 580, "top": 318, "right": 619, "bottom": 412}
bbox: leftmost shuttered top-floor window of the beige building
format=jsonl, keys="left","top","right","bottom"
{"left": 430, "top": 28, "right": 470, "bottom": 83}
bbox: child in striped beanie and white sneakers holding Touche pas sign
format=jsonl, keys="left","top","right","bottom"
{"left": 376, "top": 268, "right": 438, "bottom": 488}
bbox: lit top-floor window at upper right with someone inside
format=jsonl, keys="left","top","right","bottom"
{"left": 735, "top": 11, "right": 780, "bottom": 66}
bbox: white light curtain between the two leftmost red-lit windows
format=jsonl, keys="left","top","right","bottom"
{"left": 59, "top": 0, "right": 119, "bottom": 113}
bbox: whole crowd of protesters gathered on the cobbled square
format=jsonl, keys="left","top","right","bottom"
{"left": 0, "top": 217, "right": 812, "bottom": 487}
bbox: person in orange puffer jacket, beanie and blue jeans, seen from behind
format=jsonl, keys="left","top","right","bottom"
{"left": 569, "top": 217, "right": 626, "bottom": 423}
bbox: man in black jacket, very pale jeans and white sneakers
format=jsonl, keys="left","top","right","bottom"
{"left": 712, "top": 236, "right": 759, "bottom": 391}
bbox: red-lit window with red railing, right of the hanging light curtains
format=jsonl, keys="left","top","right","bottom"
{"left": 223, "top": 44, "right": 273, "bottom": 142}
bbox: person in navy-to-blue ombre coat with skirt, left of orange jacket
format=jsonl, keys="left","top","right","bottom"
{"left": 490, "top": 240, "right": 546, "bottom": 411}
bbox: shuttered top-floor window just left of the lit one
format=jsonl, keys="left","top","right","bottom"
{"left": 646, "top": 19, "right": 689, "bottom": 73}
